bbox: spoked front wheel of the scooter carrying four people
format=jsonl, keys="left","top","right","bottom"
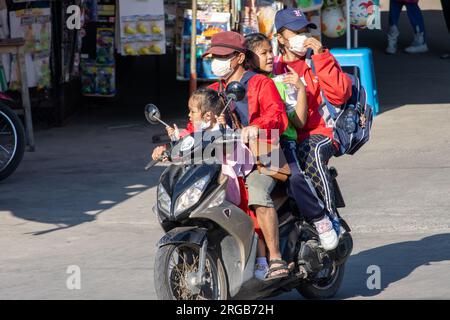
{"left": 154, "top": 243, "right": 228, "bottom": 300}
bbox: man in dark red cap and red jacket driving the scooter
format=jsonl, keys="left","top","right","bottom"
{"left": 153, "top": 31, "right": 289, "bottom": 279}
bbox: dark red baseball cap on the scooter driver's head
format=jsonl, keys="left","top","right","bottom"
{"left": 202, "top": 31, "right": 246, "bottom": 58}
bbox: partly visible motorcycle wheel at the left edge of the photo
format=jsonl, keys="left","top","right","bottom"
{"left": 0, "top": 102, "right": 25, "bottom": 181}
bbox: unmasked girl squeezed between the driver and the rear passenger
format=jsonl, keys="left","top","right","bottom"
{"left": 246, "top": 33, "right": 337, "bottom": 252}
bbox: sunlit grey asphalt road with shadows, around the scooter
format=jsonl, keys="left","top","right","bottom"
{"left": 0, "top": 104, "right": 450, "bottom": 299}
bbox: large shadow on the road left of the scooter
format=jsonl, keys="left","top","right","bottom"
{"left": 0, "top": 119, "right": 164, "bottom": 236}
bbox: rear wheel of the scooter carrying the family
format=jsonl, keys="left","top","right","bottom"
{"left": 296, "top": 264, "right": 345, "bottom": 299}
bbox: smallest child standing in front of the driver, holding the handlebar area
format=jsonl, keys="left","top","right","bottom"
{"left": 166, "top": 88, "right": 269, "bottom": 280}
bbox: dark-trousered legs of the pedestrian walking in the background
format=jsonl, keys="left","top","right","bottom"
{"left": 386, "top": 0, "right": 428, "bottom": 54}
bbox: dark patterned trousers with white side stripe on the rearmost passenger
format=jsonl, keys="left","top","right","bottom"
{"left": 298, "top": 135, "right": 336, "bottom": 216}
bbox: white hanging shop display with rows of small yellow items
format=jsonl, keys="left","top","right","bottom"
{"left": 119, "top": 0, "right": 166, "bottom": 56}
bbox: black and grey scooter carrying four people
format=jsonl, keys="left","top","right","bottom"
{"left": 145, "top": 82, "right": 353, "bottom": 300}
